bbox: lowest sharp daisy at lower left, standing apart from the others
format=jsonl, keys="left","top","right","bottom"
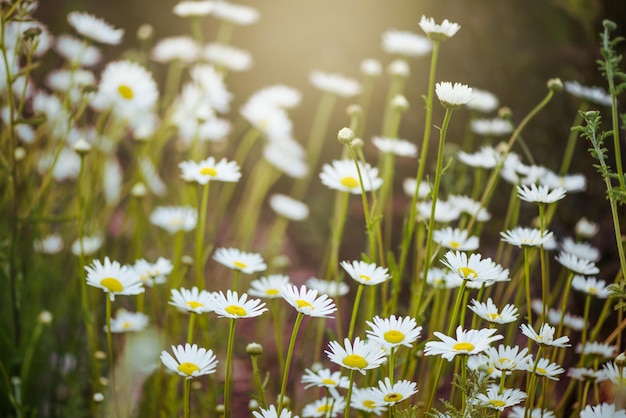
{"left": 161, "top": 344, "right": 218, "bottom": 379}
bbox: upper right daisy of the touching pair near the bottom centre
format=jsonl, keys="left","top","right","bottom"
{"left": 366, "top": 315, "right": 422, "bottom": 348}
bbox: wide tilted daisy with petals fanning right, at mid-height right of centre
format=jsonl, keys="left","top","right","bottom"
{"left": 441, "top": 251, "right": 509, "bottom": 283}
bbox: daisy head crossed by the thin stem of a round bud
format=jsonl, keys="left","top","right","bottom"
{"left": 320, "top": 160, "right": 383, "bottom": 194}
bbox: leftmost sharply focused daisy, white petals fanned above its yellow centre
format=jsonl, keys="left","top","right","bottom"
{"left": 85, "top": 257, "right": 144, "bottom": 301}
